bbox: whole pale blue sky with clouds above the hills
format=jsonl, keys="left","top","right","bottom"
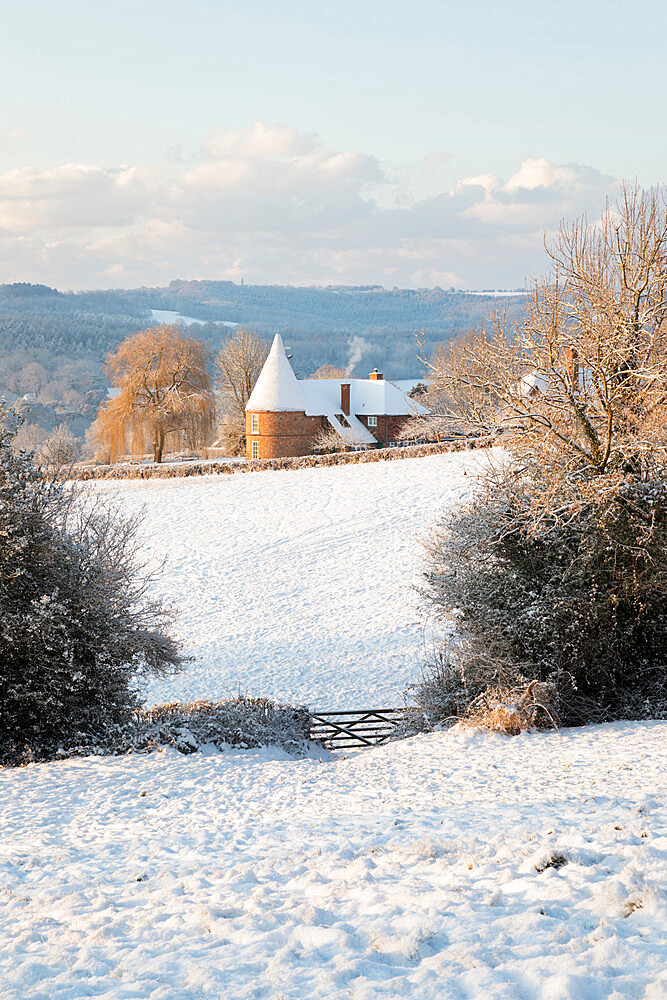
{"left": 0, "top": 0, "right": 667, "bottom": 288}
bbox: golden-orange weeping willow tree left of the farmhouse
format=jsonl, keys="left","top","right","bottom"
{"left": 98, "top": 326, "right": 215, "bottom": 462}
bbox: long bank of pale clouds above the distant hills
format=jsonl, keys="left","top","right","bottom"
{"left": 0, "top": 123, "right": 618, "bottom": 288}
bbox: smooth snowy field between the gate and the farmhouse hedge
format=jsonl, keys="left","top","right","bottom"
{"left": 95, "top": 452, "right": 485, "bottom": 709}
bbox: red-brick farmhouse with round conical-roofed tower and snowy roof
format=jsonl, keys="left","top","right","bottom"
{"left": 246, "top": 334, "right": 427, "bottom": 459}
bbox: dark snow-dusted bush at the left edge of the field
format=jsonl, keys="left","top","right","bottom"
{"left": 0, "top": 402, "right": 180, "bottom": 759}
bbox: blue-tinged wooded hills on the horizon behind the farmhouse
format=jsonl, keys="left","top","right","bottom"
{"left": 0, "top": 280, "right": 524, "bottom": 438}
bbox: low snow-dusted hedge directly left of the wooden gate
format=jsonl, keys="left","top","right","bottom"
{"left": 6, "top": 697, "right": 310, "bottom": 763}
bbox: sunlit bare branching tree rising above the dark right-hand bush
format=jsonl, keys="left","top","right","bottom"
{"left": 424, "top": 186, "right": 667, "bottom": 474}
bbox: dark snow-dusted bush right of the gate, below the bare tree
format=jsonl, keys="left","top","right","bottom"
{"left": 415, "top": 468, "right": 667, "bottom": 724}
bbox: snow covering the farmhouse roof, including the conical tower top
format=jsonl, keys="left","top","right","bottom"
{"left": 246, "top": 333, "right": 428, "bottom": 418}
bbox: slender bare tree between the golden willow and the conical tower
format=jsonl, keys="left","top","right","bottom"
{"left": 215, "top": 327, "right": 269, "bottom": 454}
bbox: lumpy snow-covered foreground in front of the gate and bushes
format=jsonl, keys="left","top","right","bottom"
{"left": 0, "top": 720, "right": 667, "bottom": 1000}
